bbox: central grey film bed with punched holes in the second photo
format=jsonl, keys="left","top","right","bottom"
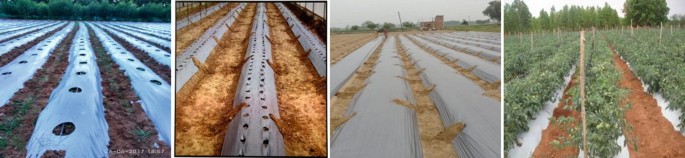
{"left": 221, "top": 3, "right": 287, "bottom": 156}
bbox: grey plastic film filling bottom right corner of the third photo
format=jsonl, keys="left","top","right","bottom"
{"left": 401, "top": 37, "right": 502, "bottom": 157}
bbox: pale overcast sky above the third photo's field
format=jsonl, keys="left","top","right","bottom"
{"left": 329, "top": 0, "right": 491, "bottom": 27}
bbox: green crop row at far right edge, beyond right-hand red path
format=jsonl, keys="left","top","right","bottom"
{"left": 605, "top": 30, "right": 685, "bottom": 132}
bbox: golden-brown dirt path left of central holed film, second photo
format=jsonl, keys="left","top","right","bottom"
{"left": 175, "top": 4, "right": 256, "bottom": 155}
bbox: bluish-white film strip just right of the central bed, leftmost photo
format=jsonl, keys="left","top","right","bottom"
{"left": 88, "top": 23, "right": 171, "bottom": 144}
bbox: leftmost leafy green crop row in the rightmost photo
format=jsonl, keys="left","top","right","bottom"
{"left": 504, "top": 34, "right": 579, "bottom": 154}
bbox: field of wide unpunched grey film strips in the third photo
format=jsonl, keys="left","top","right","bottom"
{"left": 330, "top": 32, "right": 501, "bottom": 157}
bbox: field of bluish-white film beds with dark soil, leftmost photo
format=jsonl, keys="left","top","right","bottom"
{"left": 0, "top": 19, "right": 171, "bottom": 157}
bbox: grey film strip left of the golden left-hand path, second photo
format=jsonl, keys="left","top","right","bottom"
{"left": 175, "top": 3, "right": 246, "bottom": 92}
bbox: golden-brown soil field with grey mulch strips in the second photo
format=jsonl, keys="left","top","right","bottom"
{"left": 175, "top": 2, "right": 327, "bottom": 156}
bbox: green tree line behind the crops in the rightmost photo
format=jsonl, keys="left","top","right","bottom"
{"left": 504, "top": 0, "right": 675, "bottom": 33}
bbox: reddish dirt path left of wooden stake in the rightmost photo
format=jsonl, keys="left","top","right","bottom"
{"left": 533, "top": 73, "right": 580, "bottom": 158}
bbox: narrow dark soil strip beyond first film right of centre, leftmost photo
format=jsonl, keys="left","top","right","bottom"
{"left": 102, "top": 28, "right": 171, "bottom": 84}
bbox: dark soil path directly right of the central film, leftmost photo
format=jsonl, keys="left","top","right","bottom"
{"left": 88, "top": 27, "right": 171, "bottom": 157}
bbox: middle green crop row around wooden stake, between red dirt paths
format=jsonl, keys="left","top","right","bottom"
{"left": 556, "top": 32, "right": 632, "bottom": 157}
